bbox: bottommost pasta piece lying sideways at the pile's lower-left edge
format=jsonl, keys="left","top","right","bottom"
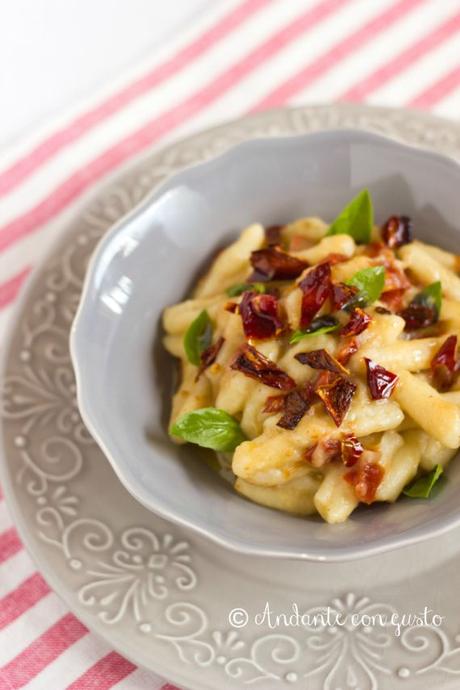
{"left": 235, "top": 472, "right": 321, "bottom": 515}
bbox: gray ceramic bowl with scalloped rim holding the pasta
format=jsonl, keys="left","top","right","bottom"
{"left": 71, "top": 130, "right": 460, "bottom": 561}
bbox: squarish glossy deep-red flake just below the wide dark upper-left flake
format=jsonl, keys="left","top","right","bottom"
{"left": 239, "top": 291, "right": 283, "bottom": 340}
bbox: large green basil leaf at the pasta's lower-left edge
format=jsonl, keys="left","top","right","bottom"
{"left": 171, "top": 407, "right": 245, "bottom": 453}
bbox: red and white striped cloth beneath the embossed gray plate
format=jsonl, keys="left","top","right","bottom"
{"left": 0, "top": 0, "right": 460, "bottom": 690}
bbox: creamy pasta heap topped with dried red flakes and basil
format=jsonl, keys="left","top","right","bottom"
{"left": 163, "top": 190, "right": 460, "bottom": 523}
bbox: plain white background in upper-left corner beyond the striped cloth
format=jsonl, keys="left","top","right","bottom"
{"left": 0, "top": 0, "right": 217, "bottom": 148}
